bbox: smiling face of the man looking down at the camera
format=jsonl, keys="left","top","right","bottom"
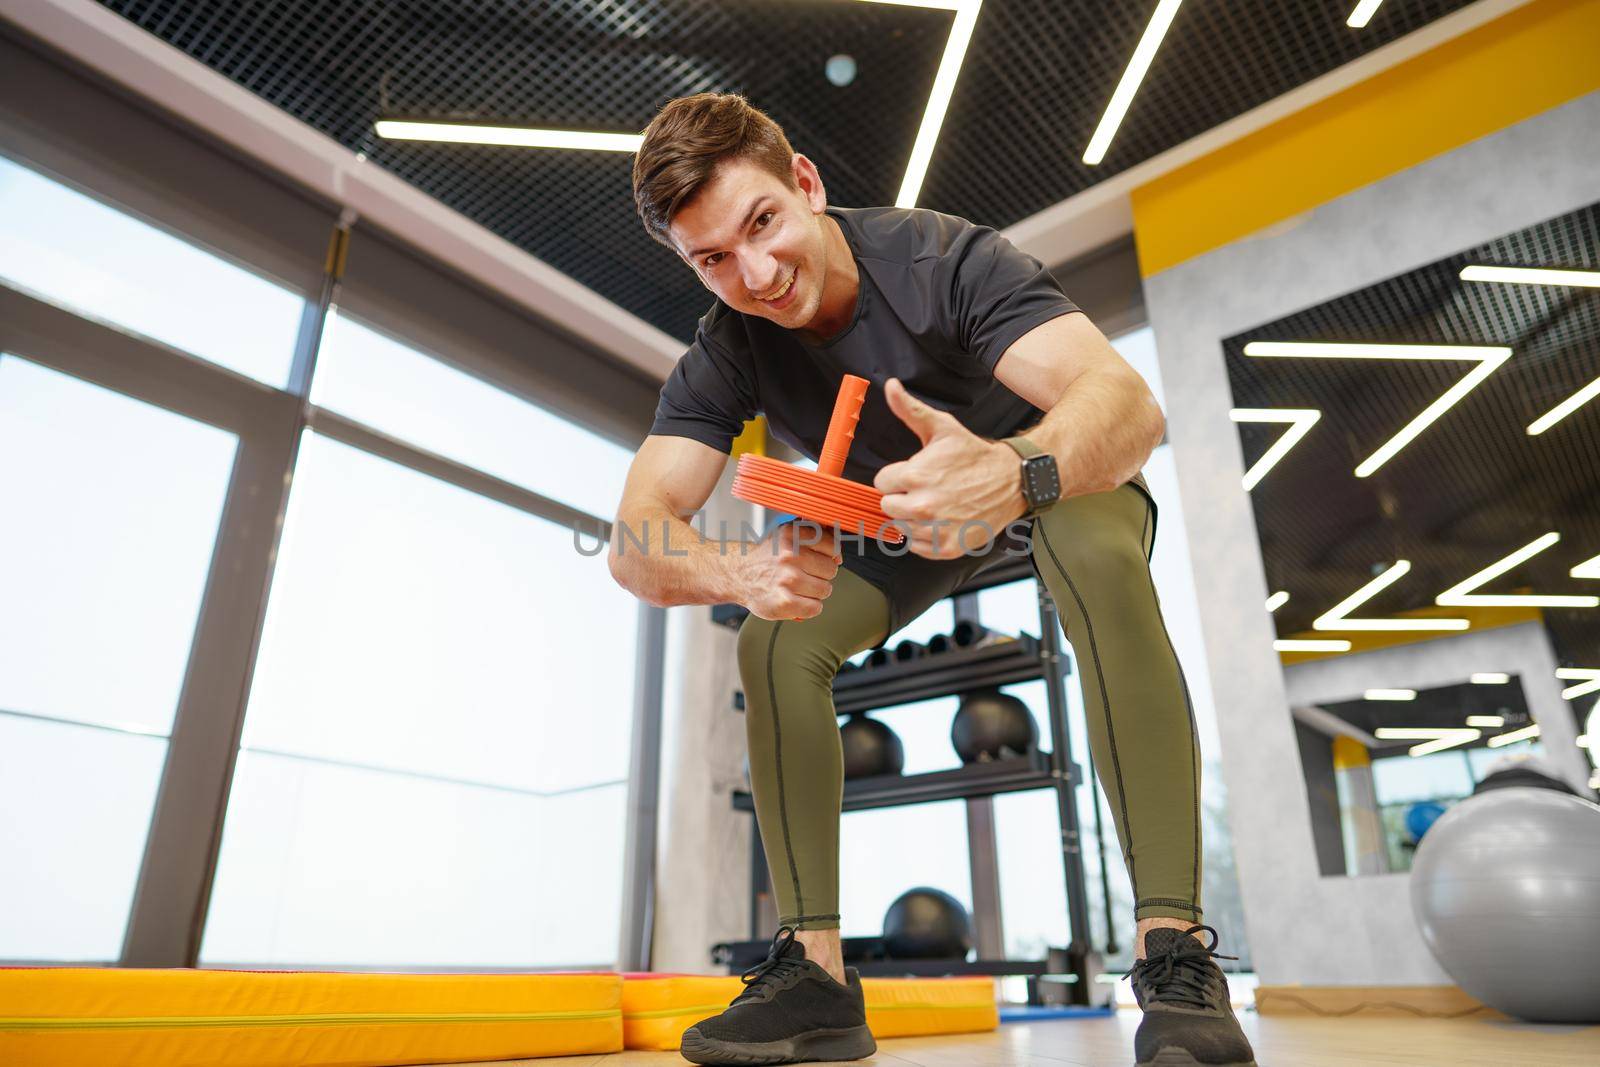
{"left": 669, "top": 155, "right": 827, "bottom": 330}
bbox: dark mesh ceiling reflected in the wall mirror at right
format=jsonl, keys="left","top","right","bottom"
{"left": 1222, "top": 205, "right": 1600, "bottom": 670}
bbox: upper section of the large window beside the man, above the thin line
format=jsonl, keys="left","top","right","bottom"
{"left": 245, "top": 434, "right": 638, "bottom": 792}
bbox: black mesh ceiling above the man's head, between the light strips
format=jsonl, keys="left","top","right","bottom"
{"left": 101, "top": 0, "right": 1469, "bottom": 339}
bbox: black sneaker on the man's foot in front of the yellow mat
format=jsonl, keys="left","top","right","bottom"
{"left": 682, "top": 926, "right": 878, "bottom": 1067}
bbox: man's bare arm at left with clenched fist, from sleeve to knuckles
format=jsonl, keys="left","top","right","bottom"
{"left": 608, "top": 435, "right": 838, "bottom": 619}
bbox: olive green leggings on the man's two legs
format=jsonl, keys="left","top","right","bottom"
{"left": 739, "top": 485, "right": 1200, "bottom": 929}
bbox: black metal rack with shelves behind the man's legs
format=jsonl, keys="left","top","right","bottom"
{"left": 712, "top": 558, "right": 1101, "bottom": 1005}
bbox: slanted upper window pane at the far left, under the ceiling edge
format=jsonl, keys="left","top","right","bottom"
{"left": 0, "top": 157, "right": 306, "bottom": 387}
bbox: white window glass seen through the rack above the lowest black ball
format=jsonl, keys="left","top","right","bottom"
{"left": 838, "top": 800, "right": 973, "bottom": 937}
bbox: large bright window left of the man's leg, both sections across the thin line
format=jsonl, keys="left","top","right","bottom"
{"left": 202, "top": 434, "right": 638, "bottom": 966}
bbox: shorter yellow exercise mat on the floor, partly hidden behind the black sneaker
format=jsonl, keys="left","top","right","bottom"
{"left": 622, "top": 974, "right": 1000, "bottom": 1051}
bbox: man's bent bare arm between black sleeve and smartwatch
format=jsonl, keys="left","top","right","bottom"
{"left": 995, "top": 314, "right": 1166, "bottom": 496}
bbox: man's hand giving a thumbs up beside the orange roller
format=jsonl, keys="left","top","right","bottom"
{"left": 872, "top": 378, "right": 1027, "bottom": 560}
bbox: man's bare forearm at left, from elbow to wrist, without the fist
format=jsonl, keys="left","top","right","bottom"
{"left": 610, "top": 509, "right": 752, "bottom": 608}
